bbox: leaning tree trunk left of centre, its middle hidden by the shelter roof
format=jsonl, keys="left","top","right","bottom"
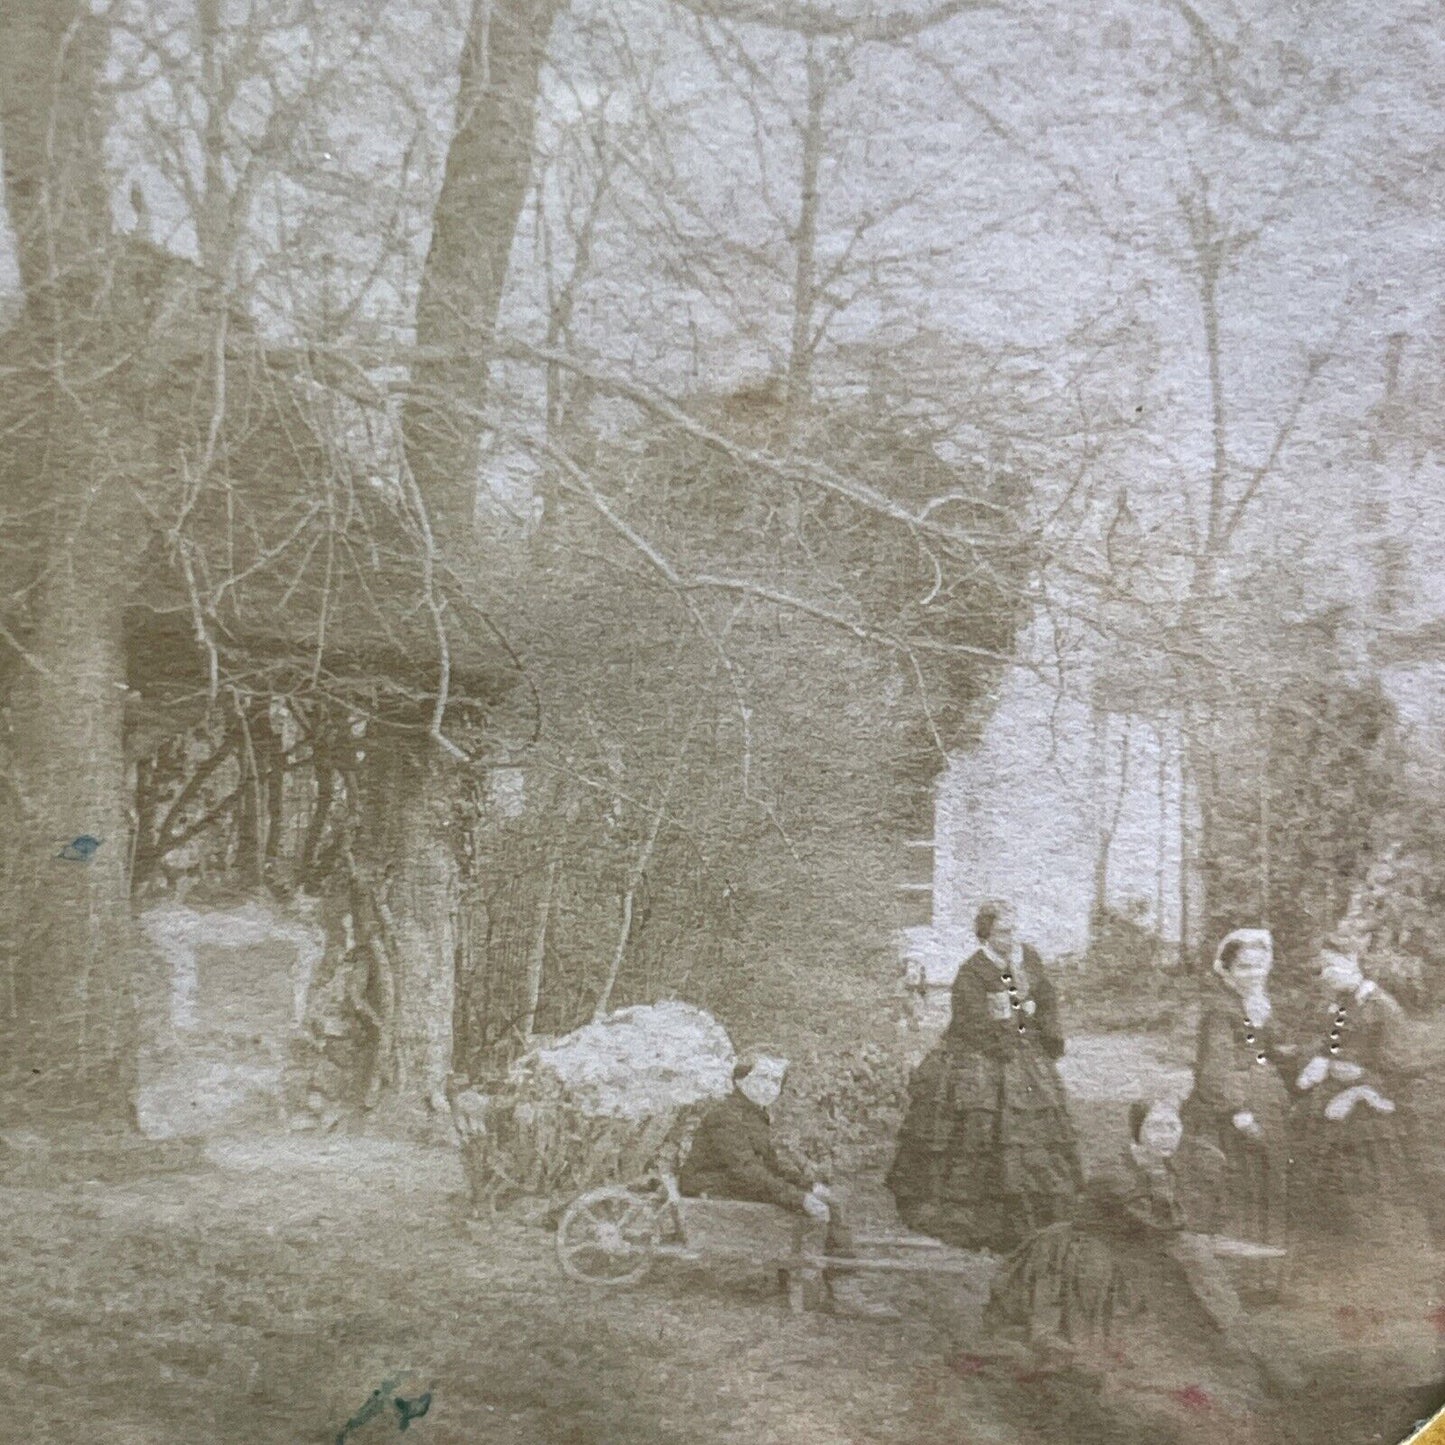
{"left": 345, "top": 0, "right": 561, "bottom": 1117}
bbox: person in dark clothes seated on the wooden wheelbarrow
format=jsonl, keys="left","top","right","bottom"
{"left": 678, "top": 1055, "right": 899, "bottom": 1319}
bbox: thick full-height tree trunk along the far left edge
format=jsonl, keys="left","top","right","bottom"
{"left": 0, "top": 0, "right": 152, "bottom": 1124}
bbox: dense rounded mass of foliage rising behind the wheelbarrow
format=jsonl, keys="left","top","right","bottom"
{"left": 447, "top": 399, "right": 1027, "bottom": 1072}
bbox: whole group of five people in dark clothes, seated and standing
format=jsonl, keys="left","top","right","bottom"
{"left": 679, "top": 902, "right": 1433, "bottom": 1438}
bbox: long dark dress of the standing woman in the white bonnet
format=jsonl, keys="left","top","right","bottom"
{"left": 1179, "top": 984, "right": 1289, "bottom": 1265}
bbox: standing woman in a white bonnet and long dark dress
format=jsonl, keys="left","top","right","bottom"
{"left": 1179, "top": 928, "right": 1289, "bottom": 1292}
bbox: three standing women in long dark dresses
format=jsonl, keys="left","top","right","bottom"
{"left": 889, "top": 903, "right": 1423, "bottom": 1253}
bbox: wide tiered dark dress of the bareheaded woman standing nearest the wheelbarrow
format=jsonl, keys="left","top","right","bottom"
{"left": 889, "top": 948, "right": 1084, "bottom": 1253}
